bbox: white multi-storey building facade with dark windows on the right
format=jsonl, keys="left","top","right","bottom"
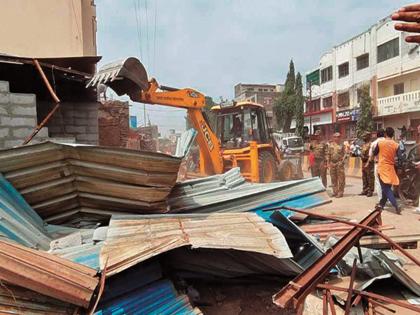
{"left": 305, "top": 17, "right": 420, "bottom": 139}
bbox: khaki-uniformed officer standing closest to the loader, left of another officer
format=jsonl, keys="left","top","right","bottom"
{"left": 310, "top": 130, "right": 328, "bottom": 188}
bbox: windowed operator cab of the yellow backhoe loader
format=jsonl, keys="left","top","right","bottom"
{"left": 212, "top": 102, "right": 271, "bottom": 149}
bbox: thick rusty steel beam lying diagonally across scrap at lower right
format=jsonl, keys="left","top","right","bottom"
{"left": 273, "top": 210, "right": 381, "bottom": 308}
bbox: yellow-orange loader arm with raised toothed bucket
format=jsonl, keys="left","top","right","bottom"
{"left": 87, "top": 58, "right": 223, "bottom": 175}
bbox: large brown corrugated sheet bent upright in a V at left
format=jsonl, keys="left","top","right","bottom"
{"left": 0, "top": 142, "right": 181, "bottom": 223}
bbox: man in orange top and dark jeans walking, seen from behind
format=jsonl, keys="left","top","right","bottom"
{"left": 375, "top": 127, "right": 401, "bottom": 214}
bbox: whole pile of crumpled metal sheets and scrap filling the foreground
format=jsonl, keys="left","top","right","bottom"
{"left": 0, "top": 139, "right": 420, "bottom": 315}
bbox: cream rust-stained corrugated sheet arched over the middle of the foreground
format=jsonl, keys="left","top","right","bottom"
{"left": 101, "top": 213, "right": 292, "bottom": 275}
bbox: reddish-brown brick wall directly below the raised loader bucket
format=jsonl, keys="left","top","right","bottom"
{"left": 98, "top": 100, "right": 130, "bottom": 148}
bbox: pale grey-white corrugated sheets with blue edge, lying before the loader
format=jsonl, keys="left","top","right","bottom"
{"left": 168, "top": 169, "right": 330, "bottom": 213}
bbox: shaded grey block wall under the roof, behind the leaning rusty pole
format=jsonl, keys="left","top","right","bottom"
{"left": 38, "top": 102, "right": 99, "bottom": 145}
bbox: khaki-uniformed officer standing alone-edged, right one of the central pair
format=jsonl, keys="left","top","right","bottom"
{"left": 328, "top": 132, "right": 346, "bottom": 198}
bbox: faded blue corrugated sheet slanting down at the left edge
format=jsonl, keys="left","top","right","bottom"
{"left": 0, "top": 174, "right": 51, "bottom": 249}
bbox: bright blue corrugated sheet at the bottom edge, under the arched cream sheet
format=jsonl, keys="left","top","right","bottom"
{"left": 95, "top": 280, "right": 201, "bottom": 315}
